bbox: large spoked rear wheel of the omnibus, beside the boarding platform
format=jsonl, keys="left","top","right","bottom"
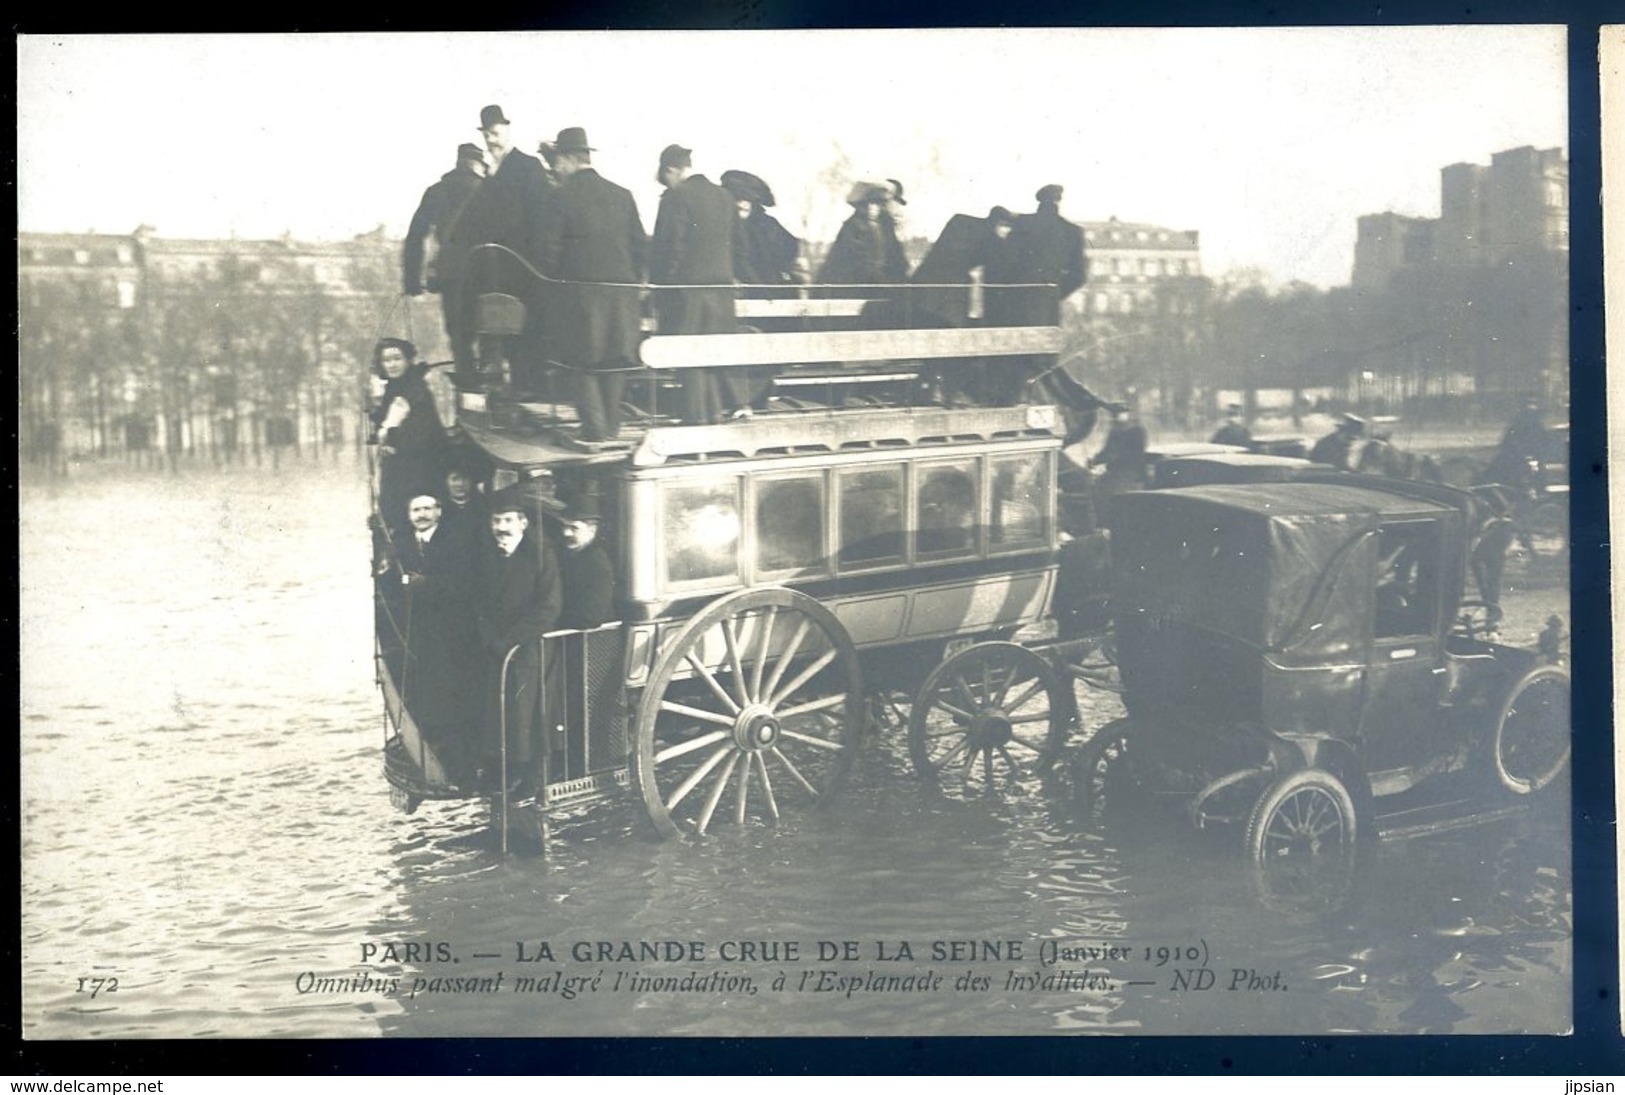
{"left": 632, "top": 586, "right": 865, "bottom": 837}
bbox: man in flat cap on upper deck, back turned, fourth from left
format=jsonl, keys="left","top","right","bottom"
{"left": 648, "top": 145, "right": 749, "bottom": 422}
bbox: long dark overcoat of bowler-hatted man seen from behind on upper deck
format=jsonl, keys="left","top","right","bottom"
{"left": 543, "top": 167, "right": 648, "bottom": 366}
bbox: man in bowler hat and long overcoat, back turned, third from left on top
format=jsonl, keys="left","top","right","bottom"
{"left": 543, "top": 127, "right": 648, "bottom": 452}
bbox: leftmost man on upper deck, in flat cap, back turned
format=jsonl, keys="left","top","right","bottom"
{"left": 401, "top": 145, "right": 486, "bottom": 374}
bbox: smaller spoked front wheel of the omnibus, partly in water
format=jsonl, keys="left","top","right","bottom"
{"left": 908, "top": 642, "right": 1073, "bottom": 798}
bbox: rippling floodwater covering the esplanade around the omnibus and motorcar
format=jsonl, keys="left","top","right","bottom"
{"left": 21, "top": 461, "right": 1573, "bottom": 1038}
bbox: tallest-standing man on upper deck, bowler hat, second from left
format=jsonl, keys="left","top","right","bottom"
{"left": 457, "top": 104, "right": 553, "bottom": 388}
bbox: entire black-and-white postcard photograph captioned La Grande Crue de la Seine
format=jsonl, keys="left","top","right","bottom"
{"left": 16, "top": 24, "right": 1573, "bottom": 1043}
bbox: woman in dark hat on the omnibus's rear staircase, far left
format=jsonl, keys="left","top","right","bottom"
{"left": 371, "top": 338, "right": 445, "bottom": 530}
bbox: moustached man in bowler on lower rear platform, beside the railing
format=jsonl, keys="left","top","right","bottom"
{"left": 476, "top": 487, "right": 562, "bottom": 793}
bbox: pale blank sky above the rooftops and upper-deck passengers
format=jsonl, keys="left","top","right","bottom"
{"left": 18, "top": 26, "right": 1568, "bottom": 288}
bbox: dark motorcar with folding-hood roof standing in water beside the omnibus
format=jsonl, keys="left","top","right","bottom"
{"left": 1077, "top": 476, "right": 1570, "bottom": 868}
